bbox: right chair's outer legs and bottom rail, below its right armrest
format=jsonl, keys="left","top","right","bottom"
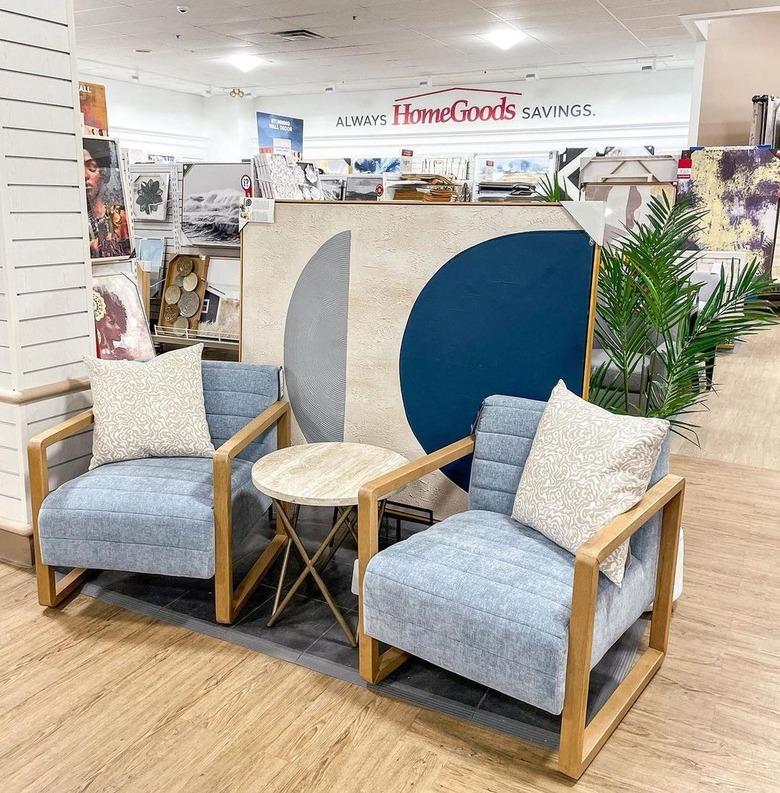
{"left": 558, "top": 487, "right": 685, "bottom": 780}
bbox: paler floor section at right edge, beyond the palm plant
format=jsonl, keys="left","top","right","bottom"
{"left": 672, "top": 325, "right": 780, "bottom": 469}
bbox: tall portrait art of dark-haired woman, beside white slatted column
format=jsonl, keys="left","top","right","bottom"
{"left": 83, "top": 136, "right": 133, "bottom": 264}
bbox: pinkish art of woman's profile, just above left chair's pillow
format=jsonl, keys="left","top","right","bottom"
{"left": 92, "top": 273, "right": 155, "bottom": 361}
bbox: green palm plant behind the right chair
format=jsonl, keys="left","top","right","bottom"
{"left": 590, "top": 195, "right": 778, "bottom": 441}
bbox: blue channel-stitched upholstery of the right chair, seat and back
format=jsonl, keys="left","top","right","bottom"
{"left": 363, "top": 396, "right": 668, "bottom": 713}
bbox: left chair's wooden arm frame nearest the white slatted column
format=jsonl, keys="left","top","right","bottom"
{"left": 27, "top": 409, "right": 95, "bottom": 606}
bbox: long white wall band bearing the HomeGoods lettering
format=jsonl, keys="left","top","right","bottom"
{"left": 264, "top": 69, "right": 693, "bottom": 145}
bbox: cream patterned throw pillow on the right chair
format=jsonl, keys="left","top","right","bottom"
{"left": 512, "top": 381, "right": 669, "bottom": 584}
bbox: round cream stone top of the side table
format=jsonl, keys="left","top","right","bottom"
{"left": 252, "top": 443, "right": 408, "bottom": 507}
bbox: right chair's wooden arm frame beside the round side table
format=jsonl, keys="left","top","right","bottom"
{"left": 358, "top": 435, "right": 474, "bottom": 683}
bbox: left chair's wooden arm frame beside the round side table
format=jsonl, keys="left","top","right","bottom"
{"left": 214, "top": 400, "right": 290, "bottom": 625}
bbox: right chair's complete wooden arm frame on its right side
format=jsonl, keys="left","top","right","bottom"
{"left": 558, "top": 474, "right": 685, "bottom": 779}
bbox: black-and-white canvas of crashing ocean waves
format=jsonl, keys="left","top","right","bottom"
{"left": 181, "top": 162, "right": 252, "bottom": 246}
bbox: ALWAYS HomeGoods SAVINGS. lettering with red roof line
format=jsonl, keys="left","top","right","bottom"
{"left": 336, "top": 88, "right": 595, "bottom": 128}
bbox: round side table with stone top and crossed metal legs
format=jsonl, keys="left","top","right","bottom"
{"left": 252, "top": 443, "right": 408, "bottom": 647}
